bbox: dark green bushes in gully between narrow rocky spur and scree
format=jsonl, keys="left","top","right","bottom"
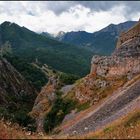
{"left": 44, "top": 97, "right": 76, "bottom": 132}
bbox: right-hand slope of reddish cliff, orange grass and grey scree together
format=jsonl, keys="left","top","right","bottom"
{"left": 56, "top": 22, "right": 140, "bottom": 138}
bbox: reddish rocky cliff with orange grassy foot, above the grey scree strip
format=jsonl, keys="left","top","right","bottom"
{"left": 60, "top": 22, "right": 140, "bottom": 118}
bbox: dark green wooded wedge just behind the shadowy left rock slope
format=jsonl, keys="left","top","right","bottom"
{"left": 6, "top": 55, "right": 48, "bottom": 90}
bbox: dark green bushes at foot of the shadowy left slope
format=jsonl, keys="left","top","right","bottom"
{"left": 0, "top": 94, "right": 36, "bottom": 131}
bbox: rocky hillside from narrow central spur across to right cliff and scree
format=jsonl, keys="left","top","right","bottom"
{"left": 25, "top": 20, "right": 140, "bottom": 137}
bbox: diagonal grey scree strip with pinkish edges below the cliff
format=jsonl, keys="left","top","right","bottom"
{"left": 63, "top": 78, "right": 140, "bottom": 135}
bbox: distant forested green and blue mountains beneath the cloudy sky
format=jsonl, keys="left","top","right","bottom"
{"left": 0, "top": 21, "right": 136, "bottom": 76}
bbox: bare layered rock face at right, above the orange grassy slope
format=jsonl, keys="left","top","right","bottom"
{"left": 90, "top": 22, "right": 140, "bottom": 77}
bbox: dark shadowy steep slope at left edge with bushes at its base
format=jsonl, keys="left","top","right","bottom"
{"left": 0, "top": 58, "right": 37, "bottom": 130}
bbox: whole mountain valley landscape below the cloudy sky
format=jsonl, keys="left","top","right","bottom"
{"left": 0, "top": 18, "right": 140, "bottom": 139}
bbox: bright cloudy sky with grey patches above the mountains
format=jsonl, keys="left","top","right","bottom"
{"left": 0, "top": 1, "right": 140, "bottom": 34}
